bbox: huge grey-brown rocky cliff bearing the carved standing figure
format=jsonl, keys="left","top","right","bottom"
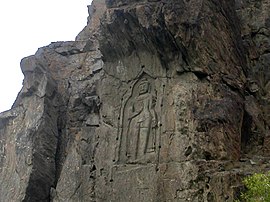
{"left": 0, "top": 0, "right": 270, "bottom": 202}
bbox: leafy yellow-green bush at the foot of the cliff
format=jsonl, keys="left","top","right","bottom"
{"left": 237, "top": 172, "right": 270, "bottom": 202}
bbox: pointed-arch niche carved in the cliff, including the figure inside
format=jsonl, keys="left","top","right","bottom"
{"left": 117, "top": 73, "right": 159, "bottom": 164}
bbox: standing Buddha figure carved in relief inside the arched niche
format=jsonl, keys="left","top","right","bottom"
{"left": 126, "top": 78, "right": 157, "bottom": 160}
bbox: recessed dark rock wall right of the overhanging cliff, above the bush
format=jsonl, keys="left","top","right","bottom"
{"left": 236, "top": 0, "right": 270, "bottom": 155}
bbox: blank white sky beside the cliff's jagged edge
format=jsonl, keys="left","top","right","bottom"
{"left": 0, "top": 0, "right": 92, "bottom": 112}
